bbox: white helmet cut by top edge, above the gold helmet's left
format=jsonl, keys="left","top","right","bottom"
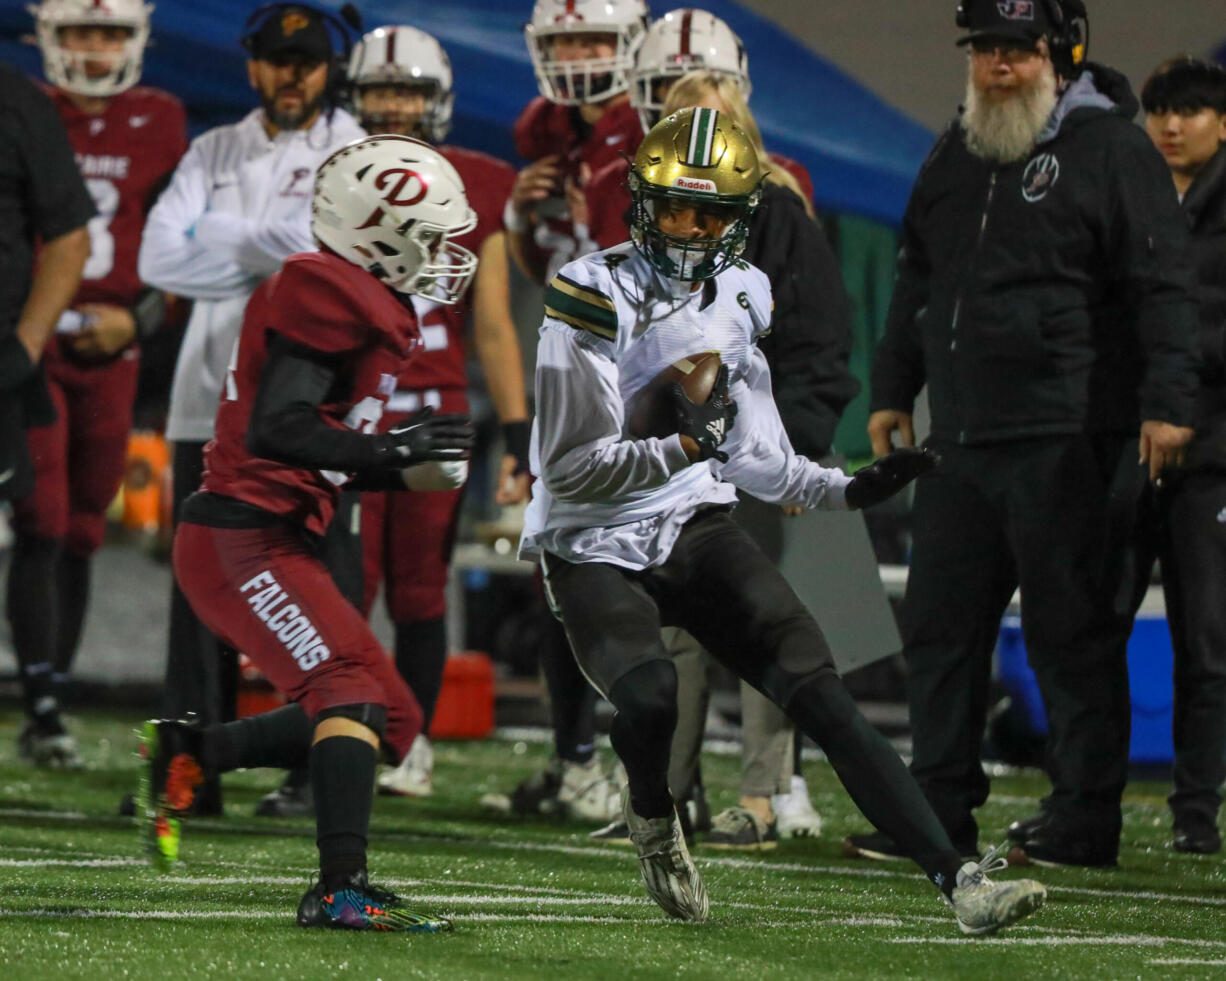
{"left": 524, "top": 0, "right": 651, "bottom": 105}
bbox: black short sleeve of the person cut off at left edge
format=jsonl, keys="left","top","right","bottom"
{"left": 15, "top": 80, "right": 97, "bottom": 242}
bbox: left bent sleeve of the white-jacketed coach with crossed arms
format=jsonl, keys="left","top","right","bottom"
{"left": 137, "top": 141, "right": 259, "bottom": 299}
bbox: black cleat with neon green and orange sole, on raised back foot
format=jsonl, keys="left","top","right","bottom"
{"left": 135, "top": 719, "right": 205, "bottom": 871}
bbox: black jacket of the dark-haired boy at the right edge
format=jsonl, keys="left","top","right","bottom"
{"left": 1183, "top": 146, "right": 1226, "bottom": 472}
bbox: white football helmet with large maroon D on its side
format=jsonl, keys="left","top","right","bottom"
{"left": 311, "top": 135, "right": 477, "bottom": 304}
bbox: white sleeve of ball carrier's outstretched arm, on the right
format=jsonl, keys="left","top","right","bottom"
{"left": 716, "top": 347, "right": 851, "bottom": 510}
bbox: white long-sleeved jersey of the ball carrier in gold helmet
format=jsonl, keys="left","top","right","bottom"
{"left": 520, "top": 243, "right": 851, "bottom": 569}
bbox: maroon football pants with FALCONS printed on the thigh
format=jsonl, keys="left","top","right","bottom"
{"left": 174, "top": 521, "right": 422, "bottom": 760}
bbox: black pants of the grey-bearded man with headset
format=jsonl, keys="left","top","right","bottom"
{"left": 902, "top": 435, "right": 1146, "bottom": 845}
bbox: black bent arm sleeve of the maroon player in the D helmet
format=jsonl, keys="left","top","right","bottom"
{"left": 246, "top": 332, "right": 395, "bottom": 473}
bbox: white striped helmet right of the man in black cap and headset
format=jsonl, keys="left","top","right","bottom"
{"left": 349, "top": 25, "right": 455, "bottom": 143}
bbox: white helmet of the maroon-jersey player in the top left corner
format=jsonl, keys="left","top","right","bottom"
{"left": 27, "top": 0, "right": 153, "bottom": 97}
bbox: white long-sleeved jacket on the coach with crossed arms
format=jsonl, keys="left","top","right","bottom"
{"left": 139, "top": 109, "right": 365, "bottom": 440}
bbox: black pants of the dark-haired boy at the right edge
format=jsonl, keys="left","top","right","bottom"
{"left": 1135, "top": 471, "right": 1226, "bottom": 825}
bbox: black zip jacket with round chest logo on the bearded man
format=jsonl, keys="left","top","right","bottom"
{"left": 872, "top": 65, "right": 1197, "bottom": 443}
